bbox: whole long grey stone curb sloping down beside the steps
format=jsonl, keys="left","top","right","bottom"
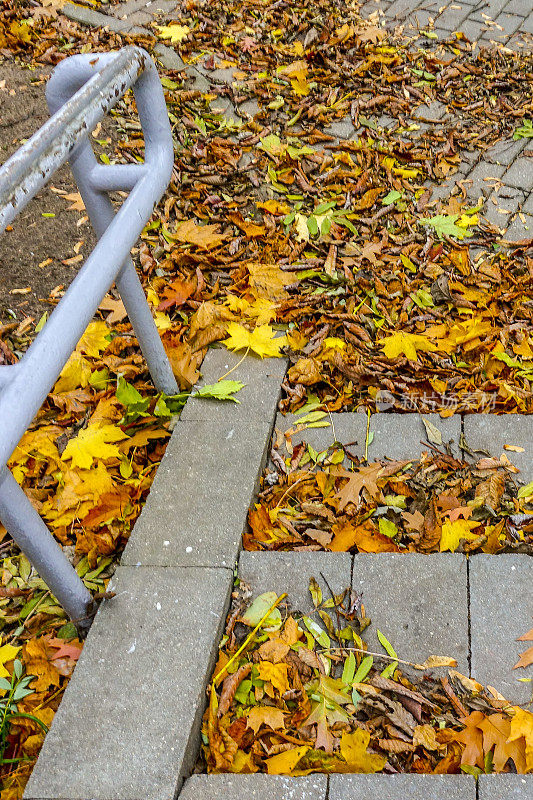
{"left": 24, "top": 351, "right": 285, "bottom": 800}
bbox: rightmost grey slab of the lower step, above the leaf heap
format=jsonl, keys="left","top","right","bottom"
{"left": 470, "top": 554, "right": 533, "bottom": 704}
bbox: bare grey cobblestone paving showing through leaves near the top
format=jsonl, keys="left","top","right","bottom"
{"left": 63, "top": 0, "right": 533, "bottom": 241}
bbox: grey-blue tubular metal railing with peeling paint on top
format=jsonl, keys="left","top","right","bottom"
{"left": 0, "top": 47, "right": 178, "bottom": 630}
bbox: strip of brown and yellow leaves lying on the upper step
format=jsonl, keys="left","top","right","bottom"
{"left": 244, "top": 422, "right": 533, "bottom": 555}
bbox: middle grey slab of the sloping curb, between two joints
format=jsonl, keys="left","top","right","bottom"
{"left": 122, "top": 418, "right": 271, "bottom": 568}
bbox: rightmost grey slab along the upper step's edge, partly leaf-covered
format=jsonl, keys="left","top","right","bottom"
{"left": 464, "top": 414, "right": 533, "bottom": 483}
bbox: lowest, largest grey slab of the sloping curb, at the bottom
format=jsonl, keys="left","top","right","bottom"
{"left": 25, "top": 567, "right": 232, "bottom": 800}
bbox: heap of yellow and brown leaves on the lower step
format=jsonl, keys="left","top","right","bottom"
{"left": 202, "top": 578, "right": 533, "bottom": 775}
